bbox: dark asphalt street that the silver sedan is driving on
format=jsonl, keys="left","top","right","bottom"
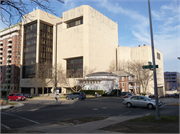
{"left": 1, "top": 98, "right": 179, "bottom": 129}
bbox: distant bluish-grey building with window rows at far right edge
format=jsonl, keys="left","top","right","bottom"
{"left": 164, "top": 72, "right": 180, "bottom": 91}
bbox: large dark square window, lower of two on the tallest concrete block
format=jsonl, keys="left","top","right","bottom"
{"left": 66, "top": 58, "right": 83, "bottom": 78}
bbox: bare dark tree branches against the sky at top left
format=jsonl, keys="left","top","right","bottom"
{"left": 0, "top": 0, "right": 64, "bottom": 26}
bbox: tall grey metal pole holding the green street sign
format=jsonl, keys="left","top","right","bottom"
{"left": 148, "top": 0, "right": 160, "bottom": 120}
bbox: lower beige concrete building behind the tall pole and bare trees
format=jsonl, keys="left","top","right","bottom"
{"left": 117, "top": 44, "right": 165, "bottom": 95}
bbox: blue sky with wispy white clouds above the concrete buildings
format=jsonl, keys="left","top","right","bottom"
{"left": 0, "top": 0, "right": 180, "bottom": 72}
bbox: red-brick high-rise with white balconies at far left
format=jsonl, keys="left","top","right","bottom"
{"left": 0, "top": 23, "right": 22, "bottom": 93}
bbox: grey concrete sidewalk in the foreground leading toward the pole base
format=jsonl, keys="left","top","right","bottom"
{"left": 15, "top": 115, "right": 144, "bottom": 133}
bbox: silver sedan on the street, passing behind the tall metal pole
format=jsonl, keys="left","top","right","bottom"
{"left": 123, "top": 95, "right": 162, "bottom": 109}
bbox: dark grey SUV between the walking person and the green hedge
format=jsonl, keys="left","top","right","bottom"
{"left": 66, "top": 92, "right": 86, "bottom": 100}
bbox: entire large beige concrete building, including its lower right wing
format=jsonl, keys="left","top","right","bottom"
{"left": 16, "top": 5, "right": 164, "bottom": 94}
